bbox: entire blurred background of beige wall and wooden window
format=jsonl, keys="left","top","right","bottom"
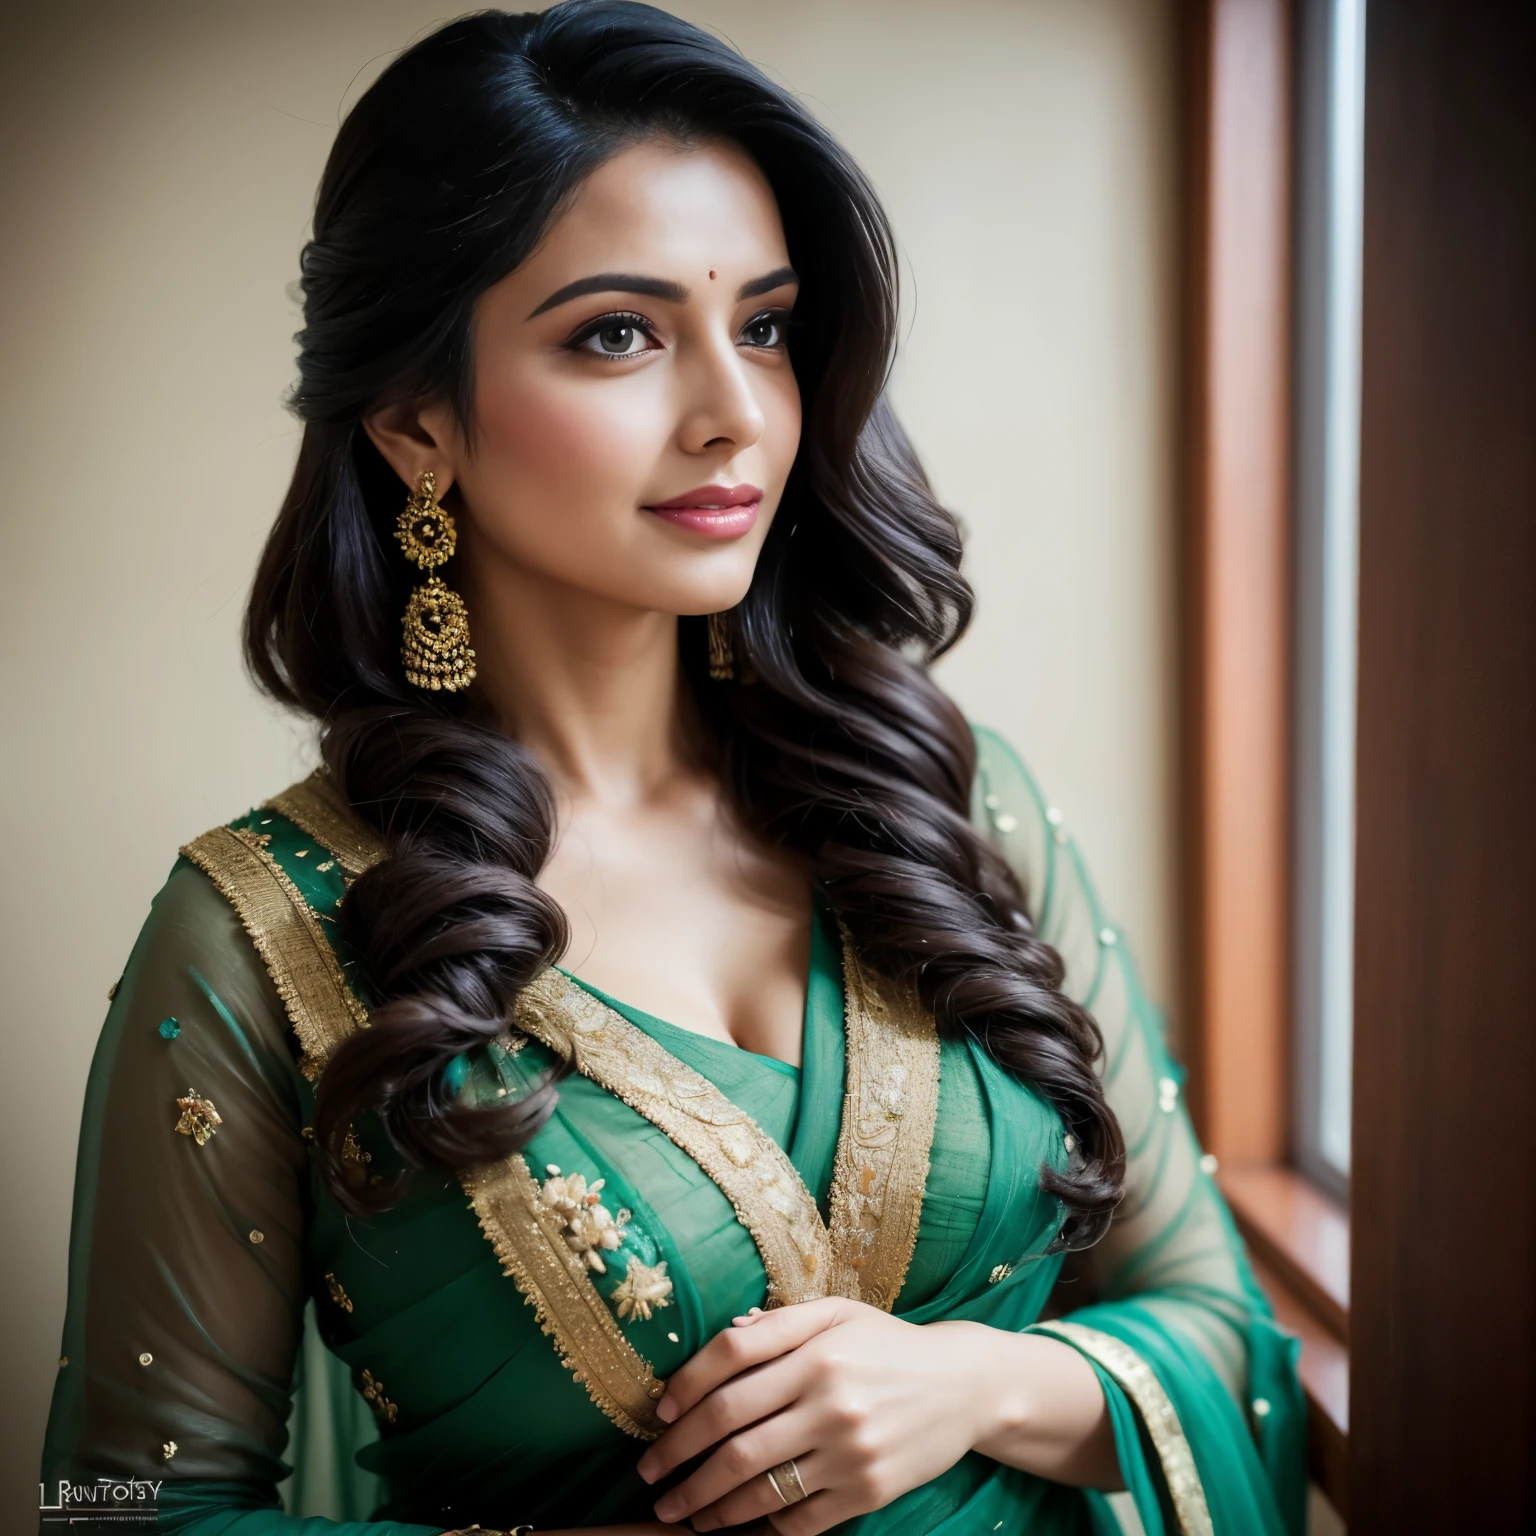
{"left": 9, "top": 0, "right": 1536, "bottom": 1536}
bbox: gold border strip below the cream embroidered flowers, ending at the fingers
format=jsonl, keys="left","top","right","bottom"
{"left": 462, "top": 1154, "right": 667, "bottom": 1439}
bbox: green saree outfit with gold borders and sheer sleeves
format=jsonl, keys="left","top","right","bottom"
{"left": 43, "top": 733, "right": 1304, "bottom": 1536}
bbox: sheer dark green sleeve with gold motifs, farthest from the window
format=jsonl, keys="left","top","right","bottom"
{"left": 43, "top": 863, "right": 439, "bottom": 1536}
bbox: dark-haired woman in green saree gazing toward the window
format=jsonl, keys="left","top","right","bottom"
{"left": 45, "top": 0, "right": 1299, "bottom": 1536}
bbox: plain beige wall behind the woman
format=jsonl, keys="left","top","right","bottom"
{"left": 0, "top": 0, "right": 1175, "bottom": 1511}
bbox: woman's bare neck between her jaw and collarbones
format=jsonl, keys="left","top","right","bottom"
{"left": 464, "top": 543, "right": 691, "bottom": 806}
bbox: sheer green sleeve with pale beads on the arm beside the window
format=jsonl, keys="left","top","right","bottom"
{"left": 974, "top": 731, "right": 1306, "bottom": 1533}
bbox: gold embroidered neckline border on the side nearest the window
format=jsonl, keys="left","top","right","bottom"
{"left": 831, "top": 934, "right": 938, "bottom": 1312}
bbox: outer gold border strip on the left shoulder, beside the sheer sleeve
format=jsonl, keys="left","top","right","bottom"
{"left": 181, "top": 826, "right": 369, "bottom": 1081}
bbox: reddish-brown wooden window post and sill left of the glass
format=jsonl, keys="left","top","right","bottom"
{"left": 1181, "top": 0, "right": 1350, "bottom": 1510}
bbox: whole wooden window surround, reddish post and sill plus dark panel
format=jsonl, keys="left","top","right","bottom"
{"left": 1181, "top": 0, "right": 1536, "bottom": 1536}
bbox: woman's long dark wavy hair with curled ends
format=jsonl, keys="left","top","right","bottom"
{"left": 246, "top": 0, "right": 1124, "bottom": 1247}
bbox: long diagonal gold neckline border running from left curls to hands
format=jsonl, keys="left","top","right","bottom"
{"left": 516, "top": 968, "right": 841, "bottom": 1307}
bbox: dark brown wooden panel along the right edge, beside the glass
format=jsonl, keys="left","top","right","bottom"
{"left": 1349, "top": 0, "right": 1536, "bottom": 1536}
